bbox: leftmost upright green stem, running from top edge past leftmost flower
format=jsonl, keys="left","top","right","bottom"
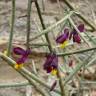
{"left": 7, "top": 0, "right": 15, "bottom": 56}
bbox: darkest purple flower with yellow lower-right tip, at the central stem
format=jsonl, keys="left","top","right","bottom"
{"left": 43, "top": 53, "right": 58, "bottom": 75}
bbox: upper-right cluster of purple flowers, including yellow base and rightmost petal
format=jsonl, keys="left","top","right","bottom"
{"left": 56, "top": 24, "right": 84, "bottom": 48}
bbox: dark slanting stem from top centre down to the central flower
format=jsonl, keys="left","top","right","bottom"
{"left": 35, "top": 0, "right": 52, "bottom": 52}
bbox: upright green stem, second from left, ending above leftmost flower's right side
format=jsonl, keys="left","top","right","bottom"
{"left": 26, "top": 0, "right": 32, "bottom": 49}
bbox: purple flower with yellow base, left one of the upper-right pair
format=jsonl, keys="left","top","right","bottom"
{"left": 56, "top": 28, "right": 69, "bottom": 48}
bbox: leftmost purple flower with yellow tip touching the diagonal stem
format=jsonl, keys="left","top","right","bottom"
{"left": 13, "top": 47, "right": 31, "bottom": 69}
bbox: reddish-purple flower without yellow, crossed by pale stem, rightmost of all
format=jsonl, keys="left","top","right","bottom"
{"left": 69, "top": 24, "right": 84, "bottom": 43}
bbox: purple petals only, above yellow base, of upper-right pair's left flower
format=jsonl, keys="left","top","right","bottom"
{"left": 56, "top": 28, "right": 69, "bottom": 44}
